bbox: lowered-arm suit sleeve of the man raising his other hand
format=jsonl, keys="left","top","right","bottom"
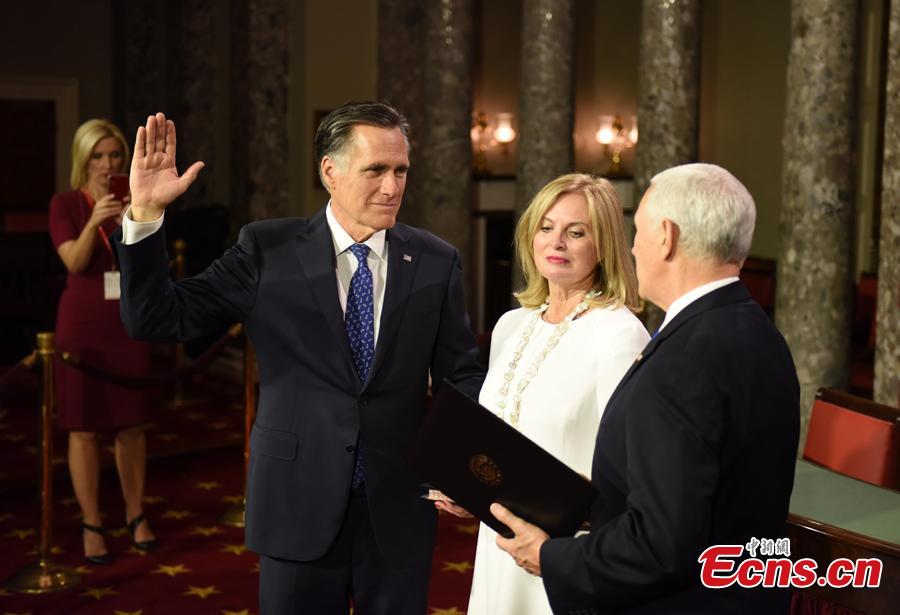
{"left": 431, "top": 250, "right": 484, "bottom": 399}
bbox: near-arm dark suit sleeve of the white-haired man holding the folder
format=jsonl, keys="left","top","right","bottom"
{"left": 541, "top": 355, "right": 725, "bottom": 613}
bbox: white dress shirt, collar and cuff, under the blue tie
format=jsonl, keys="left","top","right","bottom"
{"left": 122, "top": 201, "right": 388, "bottom": 344}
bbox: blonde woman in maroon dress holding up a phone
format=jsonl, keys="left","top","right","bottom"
{"left": 50, "top": 119, "right": 156, "bottom": 564}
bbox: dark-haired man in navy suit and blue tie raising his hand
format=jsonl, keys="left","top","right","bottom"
{"left": 116, "top": 102, "right": 483, "bottom": 615}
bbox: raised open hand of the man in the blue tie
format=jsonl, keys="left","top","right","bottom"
{"left": 129, "top": 113, "right": 204, "bottom": 222}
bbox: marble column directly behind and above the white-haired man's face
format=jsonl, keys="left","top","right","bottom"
{"left": 634, "top": 0, "right": 700, "bottom": 331}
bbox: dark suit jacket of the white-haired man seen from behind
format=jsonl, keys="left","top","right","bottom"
{"left": 541, "top": 282, "right": 800, "bottom": 614}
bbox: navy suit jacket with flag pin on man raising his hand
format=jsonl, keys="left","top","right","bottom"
{"left": 114, "top": 210, "right": 484, "bottom": 565}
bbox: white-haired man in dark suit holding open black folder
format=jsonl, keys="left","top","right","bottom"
{"left": 492, "top": 164, "right": 799, "bottom": 614}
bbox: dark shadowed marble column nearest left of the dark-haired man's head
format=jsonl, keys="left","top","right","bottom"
{"left": 231, "top": 0, "right": 289, "bottom": 223}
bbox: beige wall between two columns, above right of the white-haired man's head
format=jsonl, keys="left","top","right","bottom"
{"left": 700, "top": 0, "right": 790, "bottom": 258}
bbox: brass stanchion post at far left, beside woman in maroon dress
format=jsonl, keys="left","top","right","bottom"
{"left": 9, "top": 332, "right": 81, "bottom": 594}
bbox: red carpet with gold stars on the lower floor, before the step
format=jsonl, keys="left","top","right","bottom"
{"left": 0, "top": 447, "right": 476, "bottom": 615}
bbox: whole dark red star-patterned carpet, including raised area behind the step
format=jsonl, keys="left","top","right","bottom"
{"left": 0, "top": 366, "right": 477, "bottom": 615}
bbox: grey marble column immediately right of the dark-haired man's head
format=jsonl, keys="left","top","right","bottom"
{"left": 410, "top": 0, "right": 474, "bottom": 286}
